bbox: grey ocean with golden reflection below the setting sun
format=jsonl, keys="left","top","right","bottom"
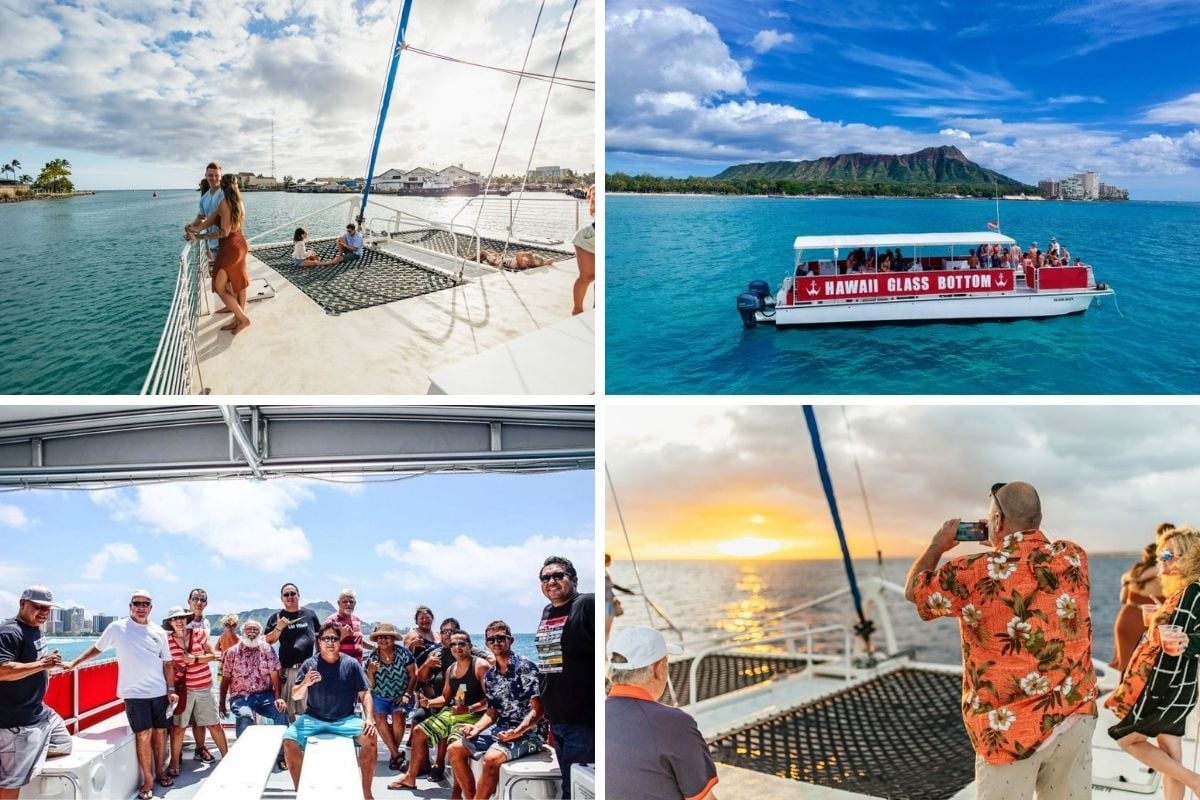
{"left": 610, "top": 553, "right": 1138, "bottom": 664}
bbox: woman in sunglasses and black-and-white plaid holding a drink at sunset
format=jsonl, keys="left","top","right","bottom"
{"left": 1104, "top": 527, "right": 1200, "bottom": 798}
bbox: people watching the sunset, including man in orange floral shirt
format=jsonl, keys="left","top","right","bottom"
{"left": 605, "top": 482, "right": 1200, "bottom": 800}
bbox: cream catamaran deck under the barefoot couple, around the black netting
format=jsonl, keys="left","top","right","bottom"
{"left": 188, "top": 240, "right": 595, "bottom": 395}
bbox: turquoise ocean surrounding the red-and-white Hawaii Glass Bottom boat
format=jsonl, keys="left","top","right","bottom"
{"left": 604, "top": 196, "right": 1200, "bottom": 395}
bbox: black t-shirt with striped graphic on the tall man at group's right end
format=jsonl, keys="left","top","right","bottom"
{"left": 536, "top": 594, "right": 596, "bottom": 728}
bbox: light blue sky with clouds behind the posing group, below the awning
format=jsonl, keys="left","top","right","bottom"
{"left": 0, "top": 470, "right": 595, "bottom": 632}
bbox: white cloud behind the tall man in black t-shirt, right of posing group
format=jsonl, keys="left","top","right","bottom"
{"left": 376, "top": 535, "right": 595, "bottom": 610}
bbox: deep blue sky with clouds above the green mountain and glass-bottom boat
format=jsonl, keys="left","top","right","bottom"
{"left": 605, "top": 0, "right": 1200, "bottom": 200}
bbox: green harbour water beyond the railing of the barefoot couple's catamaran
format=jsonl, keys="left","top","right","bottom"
{"left": 0, "top": 190, "right": 588, "bottom": 395}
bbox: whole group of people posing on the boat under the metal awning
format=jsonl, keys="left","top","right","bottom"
{"left": 0, "top": 555, "right": 595, "bottom": 800}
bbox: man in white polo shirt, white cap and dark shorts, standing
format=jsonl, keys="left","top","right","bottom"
{"left": 67, "top": 589, "right": 179, "bottom": 800}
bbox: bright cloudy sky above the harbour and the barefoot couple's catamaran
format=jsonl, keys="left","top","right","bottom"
{"left": 0, "top": 0, "right": 596, "bottom": 190}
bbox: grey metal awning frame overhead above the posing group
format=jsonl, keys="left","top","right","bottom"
{"left": 0, "top": 405, "right": 595, "bottom": 488}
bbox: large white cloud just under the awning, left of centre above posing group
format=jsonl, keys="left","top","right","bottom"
{"left": 94, "top": 480, "right": 313, "bottom": 572}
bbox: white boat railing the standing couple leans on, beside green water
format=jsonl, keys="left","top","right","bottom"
{"left": 140, "top": 241, "right": 208, "bottom": 395}
